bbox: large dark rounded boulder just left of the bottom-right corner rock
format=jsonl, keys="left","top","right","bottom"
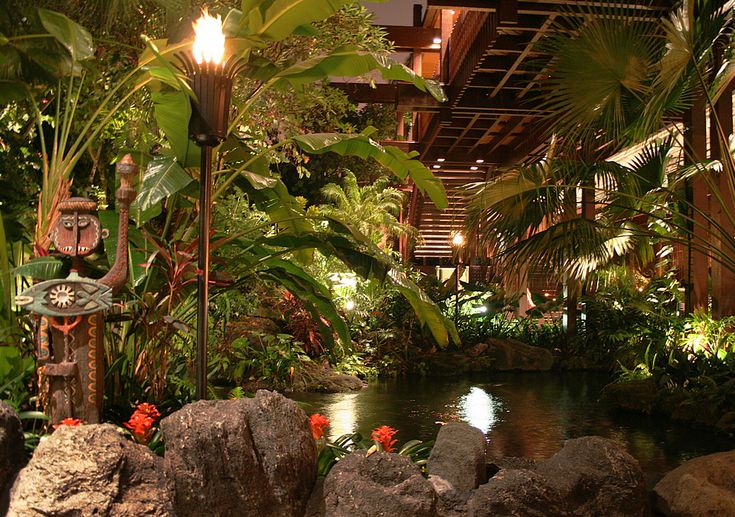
{"left": 536, "top": 436, "right": 647, "bottom": 517}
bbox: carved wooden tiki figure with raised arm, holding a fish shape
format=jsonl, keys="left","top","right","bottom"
{"left": 16, "top": 155, "right": 137, "bottom": 424}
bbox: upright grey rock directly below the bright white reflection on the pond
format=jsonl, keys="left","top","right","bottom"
{"left": 427, "top": 422, "right": 487, "bottom": 492}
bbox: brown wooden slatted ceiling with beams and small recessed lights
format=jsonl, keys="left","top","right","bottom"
{"left": 340, "top": 0, "right": 667, "bottom": 265}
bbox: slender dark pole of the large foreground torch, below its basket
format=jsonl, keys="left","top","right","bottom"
{"left": 196, "top": 145, "right": 212, "bottom": 400}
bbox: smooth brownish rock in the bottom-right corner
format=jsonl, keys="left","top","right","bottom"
{"left": 653, "top": 450, "right": 735, "bottom": 517}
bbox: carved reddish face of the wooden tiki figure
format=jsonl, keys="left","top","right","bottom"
{"left": 50, "top": 197, "right": 104, "bottom": 257}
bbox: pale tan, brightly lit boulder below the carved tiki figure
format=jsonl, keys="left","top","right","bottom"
{"left": 8, "top": 424, "right": 171, "bottom": 517}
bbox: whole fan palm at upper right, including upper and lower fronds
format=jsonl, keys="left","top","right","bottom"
{"left": 468, "top": 0, "right": 735, "bottom": 306}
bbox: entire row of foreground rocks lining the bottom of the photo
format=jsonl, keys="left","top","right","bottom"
{"left": 0, "top": 391, "right": 735, "bottom": 517}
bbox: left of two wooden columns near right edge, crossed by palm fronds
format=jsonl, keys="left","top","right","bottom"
{"left": 684, "top": 96, "right": 709, "bottom": 312}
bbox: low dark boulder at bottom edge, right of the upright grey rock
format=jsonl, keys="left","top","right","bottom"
{"left": 467, "top": 469, "right": 568, "bottom": 517}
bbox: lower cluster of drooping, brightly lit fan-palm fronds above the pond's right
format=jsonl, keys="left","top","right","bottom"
{"left": 467, "top": 139, "right": 673, "bottom": 281}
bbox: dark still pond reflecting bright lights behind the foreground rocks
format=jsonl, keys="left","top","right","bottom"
{"left": 291, "top": 372, "right": 735, "bottom": 474}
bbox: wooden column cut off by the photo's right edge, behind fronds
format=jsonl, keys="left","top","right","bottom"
{"left": 710, "top": 84, "right": 735, "bottom": 318}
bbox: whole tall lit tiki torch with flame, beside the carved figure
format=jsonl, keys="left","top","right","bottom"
{"left": 178, "top": 9, "right": 237, "bottom": 400}
